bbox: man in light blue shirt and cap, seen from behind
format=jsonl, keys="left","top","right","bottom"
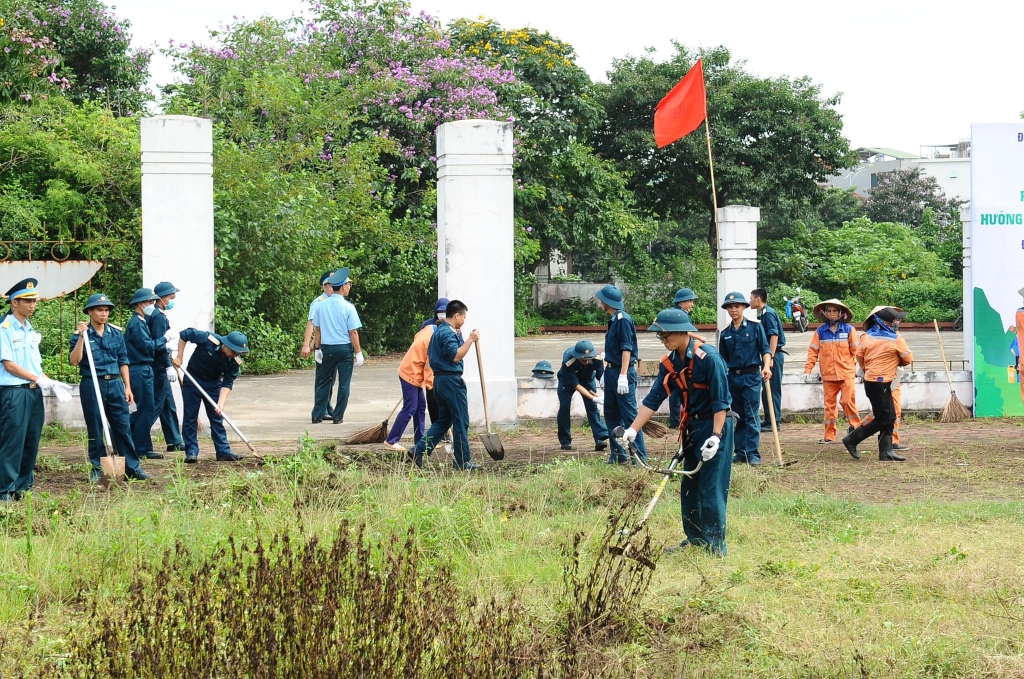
{"left": 311, "top": 266, "right": 364, "bottom": 424}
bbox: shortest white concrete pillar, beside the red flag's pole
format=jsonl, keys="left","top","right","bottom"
{"left": 715, "top": 205, "right": 761, "bottom": 330}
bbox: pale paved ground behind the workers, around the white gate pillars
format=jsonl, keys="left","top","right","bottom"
{"left": 228, "top": 331, "right": 964, "bottom": 440}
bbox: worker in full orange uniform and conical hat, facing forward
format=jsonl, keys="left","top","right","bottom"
{"left": 804, "top": 299, "right": 860, "bottom": 443}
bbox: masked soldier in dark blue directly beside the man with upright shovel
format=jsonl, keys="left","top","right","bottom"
{"left": 125, "top": 288, "right": 176, "bottom": 460}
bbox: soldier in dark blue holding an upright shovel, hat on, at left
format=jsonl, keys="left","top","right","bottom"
{"left": 69, "top": 293, "right": 150, "bottom": 481}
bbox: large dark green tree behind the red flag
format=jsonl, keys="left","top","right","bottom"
{"left": 594, "top": 43, "right": 856, "bottom": 249}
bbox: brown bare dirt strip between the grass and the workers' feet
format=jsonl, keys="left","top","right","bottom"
{"left": 28, "top": 420, "right": 1024, "bottom": 504}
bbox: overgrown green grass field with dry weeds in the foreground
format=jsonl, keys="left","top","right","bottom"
{"left": 0, "top": 426, "right": 1024, "bottom": 677}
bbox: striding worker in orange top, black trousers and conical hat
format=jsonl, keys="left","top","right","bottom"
{"left": 843, "top": 306, "right": 913, "bottom": 462}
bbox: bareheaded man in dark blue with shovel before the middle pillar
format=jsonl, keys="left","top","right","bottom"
{"left": 409, "top": 299, "right": 480, "bottom": 470}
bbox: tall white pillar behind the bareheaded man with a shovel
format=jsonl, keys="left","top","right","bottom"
{"left": 437, "top": 120, "right": 518, "bottom": 426}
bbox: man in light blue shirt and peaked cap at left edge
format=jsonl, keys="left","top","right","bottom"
{"left": 0, "top": 279, "right": 71, "bottom": 502}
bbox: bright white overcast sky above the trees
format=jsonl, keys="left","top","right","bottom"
{"left": 113, "top": 0, "right": 1024, "bottom": 153}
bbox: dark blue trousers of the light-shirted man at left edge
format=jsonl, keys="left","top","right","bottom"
{"left": 0, "top": 387, "right": 46, "bottom": 495}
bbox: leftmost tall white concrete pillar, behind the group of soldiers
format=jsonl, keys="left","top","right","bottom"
{"left": 141, "top": 116, "right": 214, "bottom": 330}
